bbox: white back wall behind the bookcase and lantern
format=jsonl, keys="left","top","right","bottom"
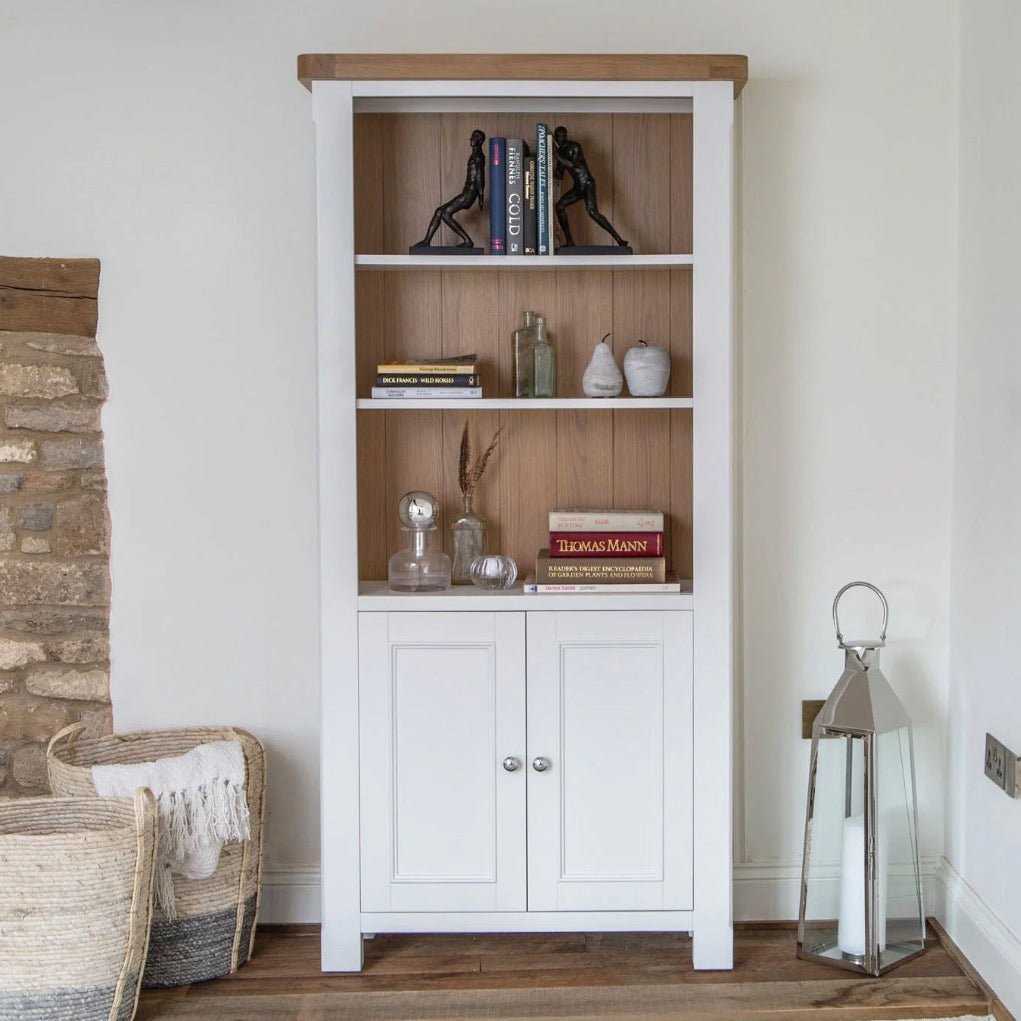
{"left": 0, "top": 0, "right": 957, "bottom": 915}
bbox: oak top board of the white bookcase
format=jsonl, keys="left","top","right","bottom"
{"left": 298, "top": 53, "right": 748, "bottom": 97}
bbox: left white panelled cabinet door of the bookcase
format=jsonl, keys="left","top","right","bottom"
{"left": 359, "top": 613, "right": 527, "bottom": 912}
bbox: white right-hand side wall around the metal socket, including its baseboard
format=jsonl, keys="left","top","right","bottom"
{"left": 946, "top": 0, "right": 1021, "bottom": 1014}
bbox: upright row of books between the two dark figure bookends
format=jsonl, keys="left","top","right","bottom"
{"left": 489, "top": 124, "right": 554, "bottom": 255}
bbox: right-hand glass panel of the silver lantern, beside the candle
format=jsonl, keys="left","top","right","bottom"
{"left": 875, "top": 727, "right": 925, "bottom": 969}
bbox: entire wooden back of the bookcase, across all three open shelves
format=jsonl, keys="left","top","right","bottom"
{"left": 355, "top": 113, "right": 692, "bottom": 580}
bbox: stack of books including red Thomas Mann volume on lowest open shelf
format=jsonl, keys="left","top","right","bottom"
{"left": 525, "top": 511, "right": 681, "bottom": 594}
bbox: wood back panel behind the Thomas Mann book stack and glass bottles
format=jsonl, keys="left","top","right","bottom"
{"left": 358, "top": 409, "right": 691, "bottom": 581}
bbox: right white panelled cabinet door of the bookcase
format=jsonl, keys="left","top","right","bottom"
{"left": 528, "top": 611, "right": 694, "bottom": 911}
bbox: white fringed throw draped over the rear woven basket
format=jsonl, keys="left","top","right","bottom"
{"left": 92, "top": 741, "right": 250, "bottom": 919}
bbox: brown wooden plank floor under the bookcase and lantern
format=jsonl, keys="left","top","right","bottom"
{"left": 137, "top": 926, "right": 1008, "bottom": 1021}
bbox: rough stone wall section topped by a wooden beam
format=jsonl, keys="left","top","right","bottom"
{"left": 0, "top": 258, "right": 111, "bottom": 799}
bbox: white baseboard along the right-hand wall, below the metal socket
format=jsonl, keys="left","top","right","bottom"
{"left": 937, "top": 859, "right": 1021, "bottom": 1017}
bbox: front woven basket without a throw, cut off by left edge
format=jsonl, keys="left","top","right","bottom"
{"left": 0, "top": 790, "right": 156, "bottom": 1021}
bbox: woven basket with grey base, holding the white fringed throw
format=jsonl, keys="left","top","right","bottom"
{"left": 46, "top": 724, "right": 265, "bottom": 988}
